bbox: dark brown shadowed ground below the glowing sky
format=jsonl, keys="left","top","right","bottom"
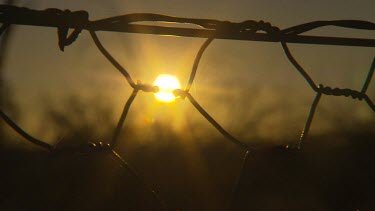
{"left": 0, "top": 129, "right": 375, "bottom": 210}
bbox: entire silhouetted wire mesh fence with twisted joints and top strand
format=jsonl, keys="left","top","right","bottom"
{"left": 0, "top": 5, "right": 375, "bottom": 210}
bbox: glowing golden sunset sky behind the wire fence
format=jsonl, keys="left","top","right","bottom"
{"left": 4, "top": 0, "right": 375, "bottom": 147}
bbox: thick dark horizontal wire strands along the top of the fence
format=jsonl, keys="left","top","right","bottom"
{"left": 0, "top": 5, "right": 375, "bottom": 47}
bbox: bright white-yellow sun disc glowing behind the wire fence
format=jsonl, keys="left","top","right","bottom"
{"left": 153, "top": 75, "right": 181, "bottom": 103}
